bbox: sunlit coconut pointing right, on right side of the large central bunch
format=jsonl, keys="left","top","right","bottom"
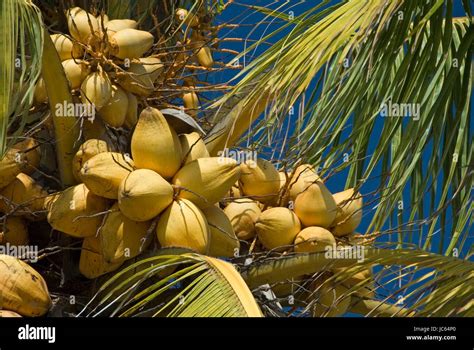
{"left": 173, "top": 157, "right": 240, "bottom": 208}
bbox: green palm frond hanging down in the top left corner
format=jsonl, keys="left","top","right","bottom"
{"left": 0, "top": 0, "right": 43, "bottom": 157}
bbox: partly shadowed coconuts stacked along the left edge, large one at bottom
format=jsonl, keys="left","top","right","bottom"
{"left": 0, "top": 138, "right": 51, "bottom": 317}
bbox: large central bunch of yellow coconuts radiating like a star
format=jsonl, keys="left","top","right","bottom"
{"left": 47, "top": 107, "right": 241, "bottom": 278}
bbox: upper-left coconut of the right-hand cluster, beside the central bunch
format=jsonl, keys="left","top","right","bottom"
{"left": 240, "top": 159, "right": 280, "bottom": 203}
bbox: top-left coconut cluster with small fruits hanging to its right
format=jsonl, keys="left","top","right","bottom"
{"left": 34, "top": 7, "right": 214, "bottom": 128}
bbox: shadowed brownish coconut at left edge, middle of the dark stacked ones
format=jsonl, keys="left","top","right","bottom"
{"left": 0, "top": 173, "right": 48, "bottom": 220}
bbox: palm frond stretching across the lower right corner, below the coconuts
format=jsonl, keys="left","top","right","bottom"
{"left": 242, "top": 245, "right": 474, "bottom": 316}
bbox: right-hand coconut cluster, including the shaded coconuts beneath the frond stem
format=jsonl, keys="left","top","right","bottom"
{"left": 224, "top": 159, "right": 373, "bottom": 316}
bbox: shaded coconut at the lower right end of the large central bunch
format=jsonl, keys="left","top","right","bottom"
{"left": 202, "top": 206, "right": 240, "bottom": 258}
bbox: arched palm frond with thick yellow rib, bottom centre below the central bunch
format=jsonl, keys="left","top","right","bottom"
{"left": 83, "top": 249, "right": 262, "bottom": 317}
